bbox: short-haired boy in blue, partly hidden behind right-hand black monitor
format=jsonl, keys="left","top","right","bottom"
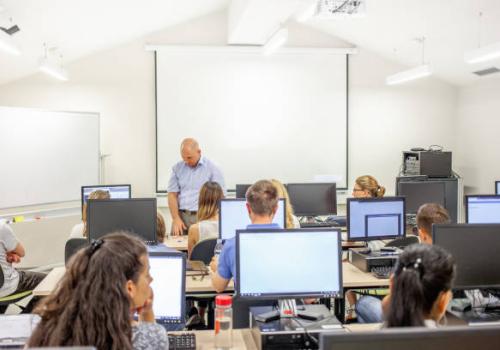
{"left": 356, "top": 203, "right": 450, "bottom": 323}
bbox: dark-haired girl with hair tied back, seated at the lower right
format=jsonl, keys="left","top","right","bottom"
{"left": 383, "top": 244, "right": 455, "bottom": 328}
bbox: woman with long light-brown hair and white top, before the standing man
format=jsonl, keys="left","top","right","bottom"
{"left": 188, "top": 181, "right": 224, "bottom": 257}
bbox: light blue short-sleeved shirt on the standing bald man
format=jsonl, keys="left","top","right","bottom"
{"left": 167, "top": 157, "right": 225, "bottom": 211}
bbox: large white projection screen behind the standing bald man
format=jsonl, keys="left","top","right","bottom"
{"left": 156, "top": 50, "right": 347, "bottom": 192}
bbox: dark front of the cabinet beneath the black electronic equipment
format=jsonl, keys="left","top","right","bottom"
{"left": 397, "top": 181, "right": 446, "bottom": 214}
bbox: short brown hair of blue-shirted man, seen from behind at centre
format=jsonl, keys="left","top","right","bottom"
{"left": 246, "top": 180, "right": 278, "bottom": 215}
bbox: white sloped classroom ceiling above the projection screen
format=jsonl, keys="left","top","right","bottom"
{"left": 0, "top": 0, "right": 500, "bottom": 86}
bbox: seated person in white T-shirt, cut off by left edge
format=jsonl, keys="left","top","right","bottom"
{"left": 0, "top": 220, "right": 45, "bottom": 312}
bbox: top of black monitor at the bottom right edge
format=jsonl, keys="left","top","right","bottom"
{"left": 319, "top": 325, "right": 500, "bottom": 350}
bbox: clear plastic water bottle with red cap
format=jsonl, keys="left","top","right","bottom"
{"left": 215, "top": 294, "right": 233, "bottom": 350}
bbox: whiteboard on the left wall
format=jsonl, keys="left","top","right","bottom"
{"left": 0, "top": 107, "right": 99, "bottom": 208}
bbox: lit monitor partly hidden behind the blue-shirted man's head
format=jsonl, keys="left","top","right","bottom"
{"left": 219, "top": 198, "right": 286, "bottom": 240}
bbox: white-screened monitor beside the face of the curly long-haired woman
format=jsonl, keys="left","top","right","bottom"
{"left": 149, "top": 252, "right": 186, "bottom": 324}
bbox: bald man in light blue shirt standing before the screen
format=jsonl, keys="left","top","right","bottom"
{"left": 167, "top": 138, "right": 224, "bottom": 236}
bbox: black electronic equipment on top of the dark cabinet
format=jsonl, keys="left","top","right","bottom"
{"left": 403, "top": 151, "right": 453, "bottom": 177}
